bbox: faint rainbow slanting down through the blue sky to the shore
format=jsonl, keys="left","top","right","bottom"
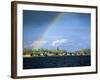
{"left": 32, "top": 13, "right": 64, "bottom": 48}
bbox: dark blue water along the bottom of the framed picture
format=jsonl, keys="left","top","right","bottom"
{"left": 23, "top": 56, "right": 91, "bottom": 69}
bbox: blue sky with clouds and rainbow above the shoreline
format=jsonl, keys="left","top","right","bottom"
{"left": 23, "top": 10, "right": 91, "bottom": 51}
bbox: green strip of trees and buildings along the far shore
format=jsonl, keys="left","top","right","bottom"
{"left": 23, "top": 48, "right": 91, "bottom": 57}
